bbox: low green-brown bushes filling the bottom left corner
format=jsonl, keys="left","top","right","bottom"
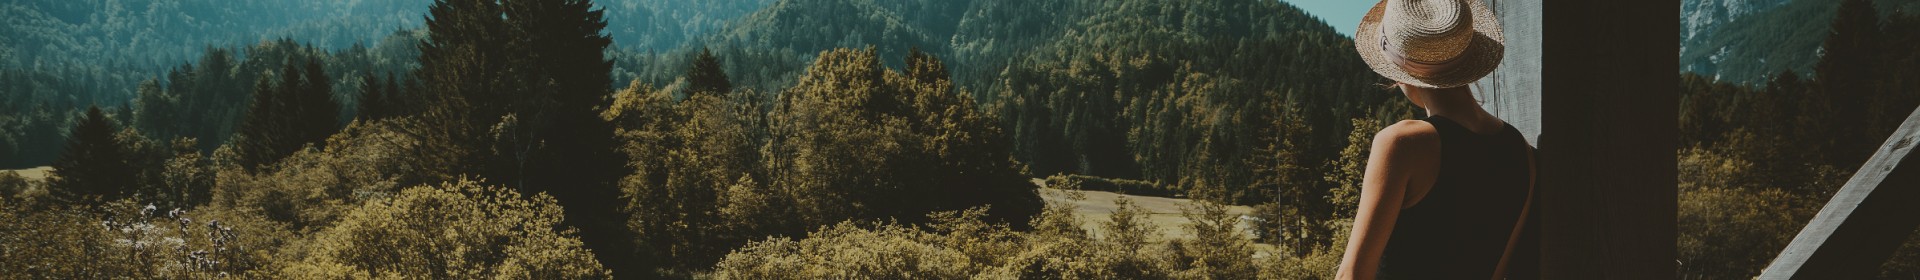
{"left": 0, "top": 199, "right": 286, "bottom": 278}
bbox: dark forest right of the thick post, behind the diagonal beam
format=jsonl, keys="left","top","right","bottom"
{"left": 1678, "top": 0, "right": 1920, "bottom": 278}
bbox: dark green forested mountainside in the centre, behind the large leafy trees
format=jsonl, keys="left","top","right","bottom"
{"left": 618, "top": 0, "right": 1386, "bottom": 201}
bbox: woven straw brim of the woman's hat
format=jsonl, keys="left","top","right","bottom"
{"left": 1354, "top": 0, "right": 1505, "bottom": 88}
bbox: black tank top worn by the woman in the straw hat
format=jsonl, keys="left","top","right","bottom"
{"left": 1380, "top": 117, "right": 1532, "bottom": 280}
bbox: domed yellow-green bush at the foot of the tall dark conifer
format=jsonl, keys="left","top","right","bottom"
{"left": 282, "top": 180, "right": 609, "bottom": 278}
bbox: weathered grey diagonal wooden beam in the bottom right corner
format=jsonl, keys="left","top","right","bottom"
{"left": 1761, "top": 109, "right": 1920, "bottom": 280}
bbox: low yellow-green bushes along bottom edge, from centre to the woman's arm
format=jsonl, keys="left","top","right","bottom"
{"left": 710, "top": 193, "right": 1338, "bottom": 280}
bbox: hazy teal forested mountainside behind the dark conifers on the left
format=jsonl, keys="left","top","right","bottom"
{"left": 0, "top": 0, "right": 779, "bottom": 169}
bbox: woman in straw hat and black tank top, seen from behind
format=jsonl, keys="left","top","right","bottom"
{"left": 1338, "top": 0, "right": 1534, "bottom": 280}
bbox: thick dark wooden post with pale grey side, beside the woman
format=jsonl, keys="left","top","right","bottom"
{"left": 1476, "top": 0, "right": 1680, "bottom": 280}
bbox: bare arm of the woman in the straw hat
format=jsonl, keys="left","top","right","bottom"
{"left": 1336, "top": 121, "right": 1440, "bottom": 280}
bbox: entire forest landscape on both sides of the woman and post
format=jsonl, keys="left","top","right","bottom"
{"left": 0, "top": 0, "right": 1920, "bottom": 278}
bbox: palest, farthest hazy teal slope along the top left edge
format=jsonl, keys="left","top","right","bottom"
{"left": 0, "top": 0, "right": 424, "bottom": 67}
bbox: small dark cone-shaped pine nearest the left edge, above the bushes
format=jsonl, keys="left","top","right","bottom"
{"left": 48, "top": 105, "right": 136, "bottom": 205}
